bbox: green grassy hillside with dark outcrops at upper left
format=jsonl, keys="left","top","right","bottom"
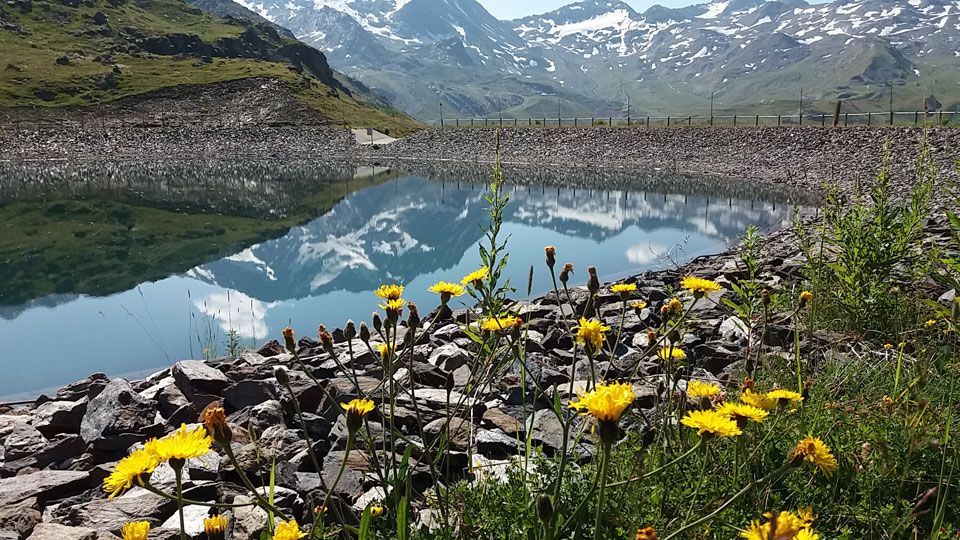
{"left": 0, "top": 0, "right": 418, "bottom": 134}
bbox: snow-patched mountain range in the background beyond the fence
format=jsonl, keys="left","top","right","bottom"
{"left": 231, "top": 0, "right": 960, "bottom": 120}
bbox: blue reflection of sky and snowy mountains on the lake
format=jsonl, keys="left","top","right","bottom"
{"left": 0, "top": 177, "right": 808, "bottom": 397}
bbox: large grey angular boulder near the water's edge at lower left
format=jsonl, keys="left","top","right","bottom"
{"left": 80, "top": 378, "right": 157, "bottom": 450}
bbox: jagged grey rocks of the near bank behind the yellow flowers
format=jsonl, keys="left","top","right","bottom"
{"left": 0, "top": 216, "right": 948, "bottom": 540}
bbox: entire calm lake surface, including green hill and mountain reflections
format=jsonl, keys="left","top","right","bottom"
{"left": 0, "top": 162, "right": 809, "bottom": 401}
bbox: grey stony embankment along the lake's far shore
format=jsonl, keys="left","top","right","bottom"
{"left": 0, "top": 124, "right": 960, "bottom": 206}
